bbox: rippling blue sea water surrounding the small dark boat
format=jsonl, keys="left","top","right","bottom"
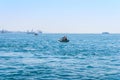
{"left": 0, "top": 33, "right": 120, "bottom": 80}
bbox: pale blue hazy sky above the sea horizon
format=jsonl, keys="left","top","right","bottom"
{"left": 0, "top": 0, "right": 120, "bottom": 33}
